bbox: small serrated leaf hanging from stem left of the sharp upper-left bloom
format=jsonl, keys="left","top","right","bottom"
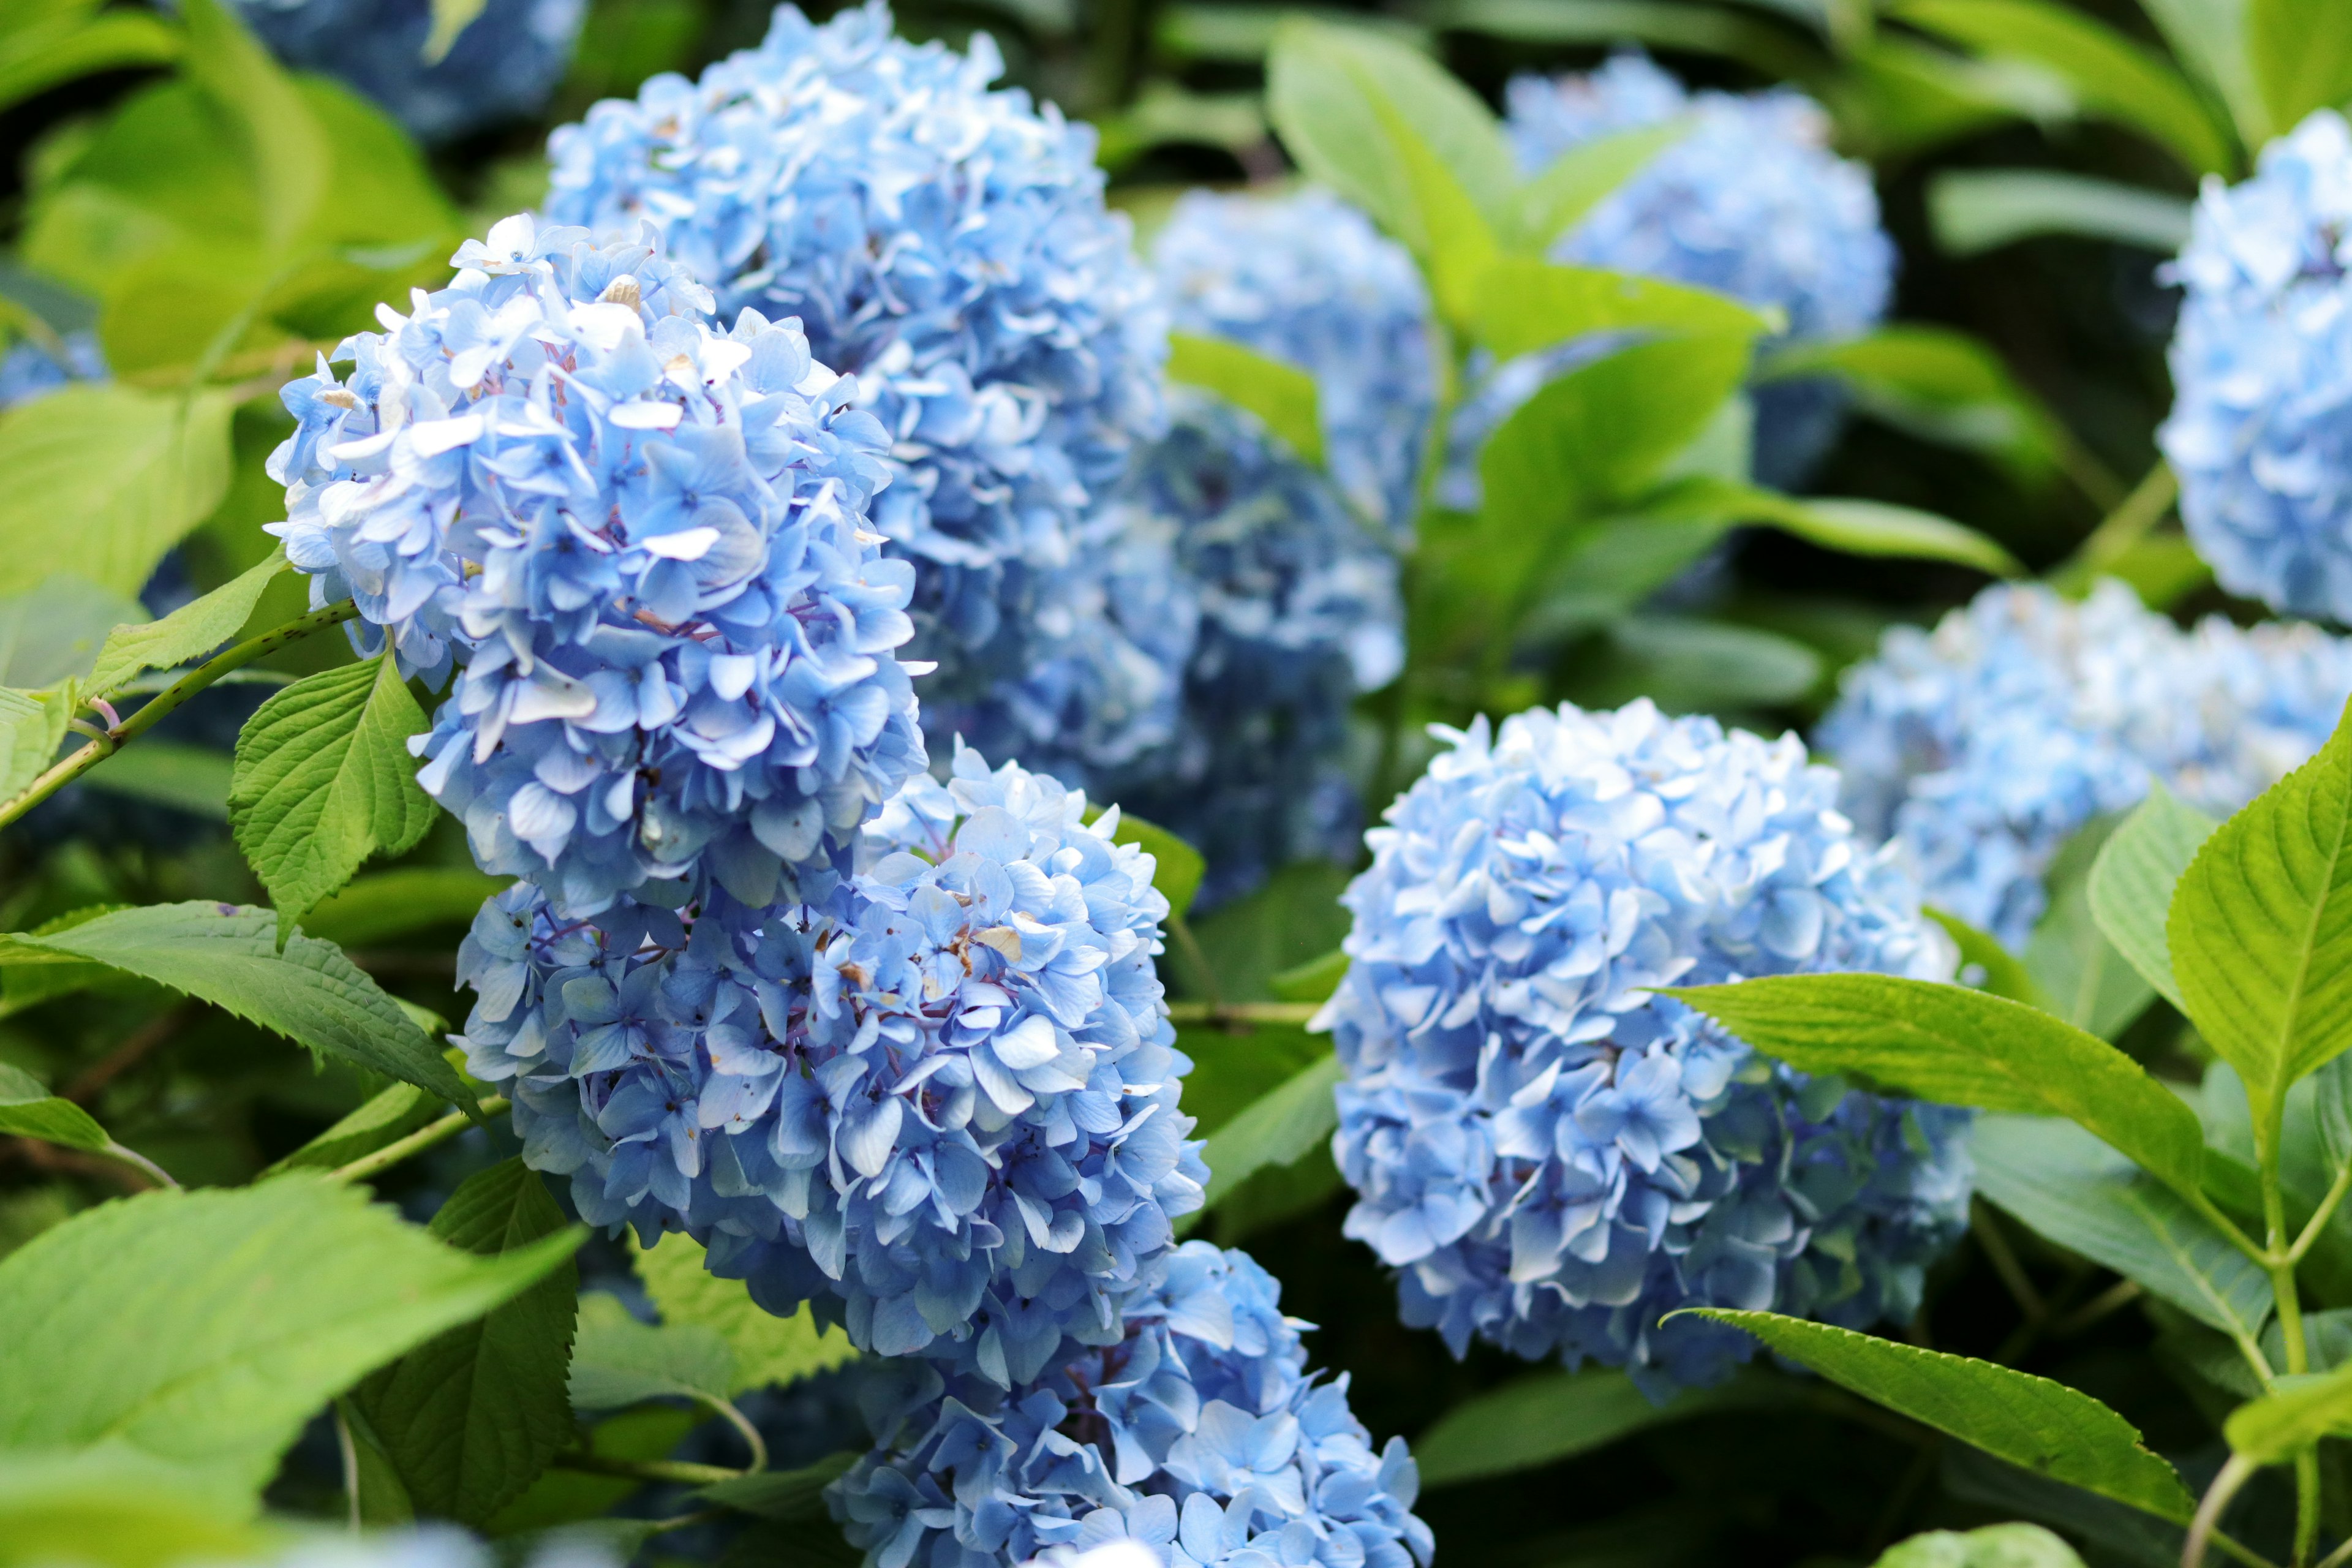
{"left": 228, "top": 649, "right": 433, "bottom": 940}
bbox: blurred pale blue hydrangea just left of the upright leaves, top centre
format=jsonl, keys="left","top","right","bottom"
{"left": 1153, "top": 188, "right": 1437, "bottom": 538}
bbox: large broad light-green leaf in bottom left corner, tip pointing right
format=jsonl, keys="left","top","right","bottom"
{"left": 0, "top": 1175, "right": 581, "bottom": 1498}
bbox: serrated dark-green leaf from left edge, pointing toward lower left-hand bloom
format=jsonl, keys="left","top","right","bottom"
{"left": 0, "top": 903, "right": 473, "bottom": 1105}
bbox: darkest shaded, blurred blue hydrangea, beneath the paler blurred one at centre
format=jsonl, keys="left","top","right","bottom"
{"left": 1103, "top": 393, "right": 1404, "bottom": 907}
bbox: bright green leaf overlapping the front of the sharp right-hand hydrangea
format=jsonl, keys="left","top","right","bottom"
{"left": 1660, "top": 976, "right": 2204, "bottom": 1194}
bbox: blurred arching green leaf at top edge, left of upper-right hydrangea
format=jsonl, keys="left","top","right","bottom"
{"left": 1896, "top": 0, "right": 2230, "bottom": 174}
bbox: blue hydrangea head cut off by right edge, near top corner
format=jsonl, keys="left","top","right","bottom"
{"left": 2157, "top": 108, "right": 2352, "bottom": 620}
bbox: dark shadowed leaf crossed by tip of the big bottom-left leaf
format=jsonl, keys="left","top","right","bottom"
{"left": 350, "top": 1156, "right": 579, "bottom": 1528}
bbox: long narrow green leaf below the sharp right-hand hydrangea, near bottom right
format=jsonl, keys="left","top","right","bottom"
{"left": 1696, "top": 1307, "right": 2197, "bottom": 1523}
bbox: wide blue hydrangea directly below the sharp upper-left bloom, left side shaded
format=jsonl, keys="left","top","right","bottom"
{"left": 459, "top": 750, "right": 1207, "bottom": 1385}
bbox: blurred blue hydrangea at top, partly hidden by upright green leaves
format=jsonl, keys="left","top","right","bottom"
{"left": 1447, "top": 54, "right": 1896, "bottom": 505}
